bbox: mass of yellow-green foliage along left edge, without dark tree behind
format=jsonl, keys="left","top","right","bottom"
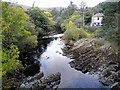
{"left": 0, "top": 2, "right": 37, "bottom": 75}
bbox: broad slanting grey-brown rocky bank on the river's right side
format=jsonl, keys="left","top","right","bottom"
{"left": 63, "top": 38, "right": 120, "bottom": 88}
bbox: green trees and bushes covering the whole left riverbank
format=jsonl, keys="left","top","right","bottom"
{"left": 0, "top": 2, "right": 59, "bottom": 89}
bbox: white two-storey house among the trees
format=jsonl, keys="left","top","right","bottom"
{"left": 90, "top": 13, "right": 104, "bottom": 27}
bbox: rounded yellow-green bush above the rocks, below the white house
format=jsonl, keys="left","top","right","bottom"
{"left": 63, "top": 25, "right": 89, "bottom": 41}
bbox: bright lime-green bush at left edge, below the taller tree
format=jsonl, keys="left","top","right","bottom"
{"left": 0, "top": 44, "right": 21, "bottom": 76}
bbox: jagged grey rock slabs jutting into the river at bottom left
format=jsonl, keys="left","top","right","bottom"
{"left": 20, "top": 73, "right": 61, "bottom": 90}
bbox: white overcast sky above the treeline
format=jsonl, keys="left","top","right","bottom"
{"left": 2, "top": 0, "right": 109, "bottom": 7}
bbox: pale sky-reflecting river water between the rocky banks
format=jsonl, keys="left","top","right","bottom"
{"left": 37, "top": 34, "right": 109, "bottom": 90}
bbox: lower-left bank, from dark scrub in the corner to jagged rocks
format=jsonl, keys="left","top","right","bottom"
{"left": 2, "top": 64, "right": 61, "bottom": 90}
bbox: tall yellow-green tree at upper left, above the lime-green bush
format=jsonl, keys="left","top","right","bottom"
{"left": 2, "top": 3, "right": 30, "bottom": 47}
